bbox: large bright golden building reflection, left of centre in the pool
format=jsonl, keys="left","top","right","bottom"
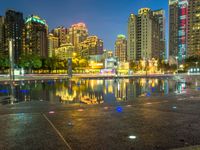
{"left": 56, "top": 80, "right": 103, "bottom": 104}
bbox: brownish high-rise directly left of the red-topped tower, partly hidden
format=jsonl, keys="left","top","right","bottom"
{"left": 52, "top": 26, "right": 67, "bottom": 46}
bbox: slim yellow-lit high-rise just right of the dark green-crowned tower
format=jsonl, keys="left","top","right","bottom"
{"left": 48, "top": 33, "right": 59, "bottom": 57}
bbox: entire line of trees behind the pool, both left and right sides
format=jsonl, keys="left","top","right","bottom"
{"left": 0, "top": 54, "right": 200, "bottom": 73}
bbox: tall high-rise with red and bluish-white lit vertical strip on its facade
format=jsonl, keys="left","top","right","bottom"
{"left": 169, "top": 0, "right": 188, "bottom": 63}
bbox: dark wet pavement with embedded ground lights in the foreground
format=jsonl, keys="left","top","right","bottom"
{"left": 0, "top": 91, "right": 200, "bottom": 150}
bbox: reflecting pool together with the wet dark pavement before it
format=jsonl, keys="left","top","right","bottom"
{"left": 0, "top": 76, "right": 200, "bottom": 150}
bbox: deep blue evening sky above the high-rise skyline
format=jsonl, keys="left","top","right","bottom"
{"left": 0, "top": 0, "right": 168, "bottom": 50}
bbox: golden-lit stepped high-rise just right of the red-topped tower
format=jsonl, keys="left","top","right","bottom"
{"left": 78, "top": 36, "right": 103, "bottom": 57}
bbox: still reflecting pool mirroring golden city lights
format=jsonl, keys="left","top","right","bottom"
{"left": 0, "top": 77, "right": 200, "bottom": 105}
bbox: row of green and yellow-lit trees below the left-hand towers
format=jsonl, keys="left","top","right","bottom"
{"left": 0, "top": 54, "right": 88, "bottom": 73}
